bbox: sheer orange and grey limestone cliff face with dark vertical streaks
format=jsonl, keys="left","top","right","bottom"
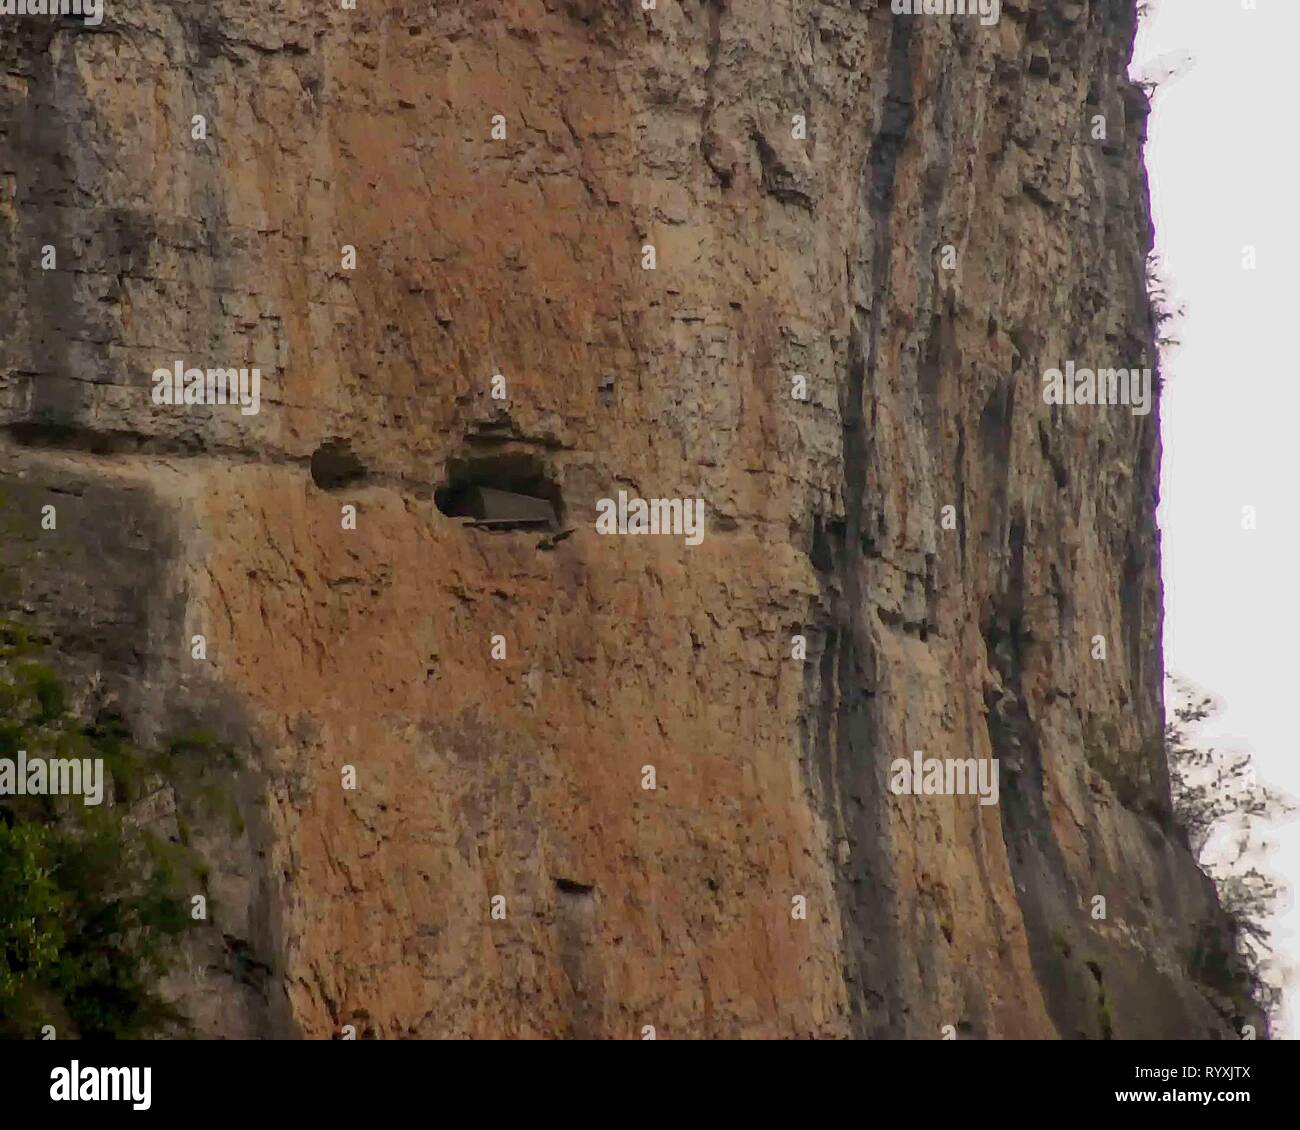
{"left": 0, "top": 0, "right": 1234, "bottom": 1039}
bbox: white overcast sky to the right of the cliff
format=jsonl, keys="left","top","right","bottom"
{"left": 1134, "top": 0, "right": 1300, "bottom": 1038}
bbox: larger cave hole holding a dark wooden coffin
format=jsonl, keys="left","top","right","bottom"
{"left": 433, "top": 453, "right": 564, "bottom": 531}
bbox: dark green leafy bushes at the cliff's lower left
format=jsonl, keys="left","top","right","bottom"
{"left": 0, "top": 622, "right": 210, "bottom": 1039}
